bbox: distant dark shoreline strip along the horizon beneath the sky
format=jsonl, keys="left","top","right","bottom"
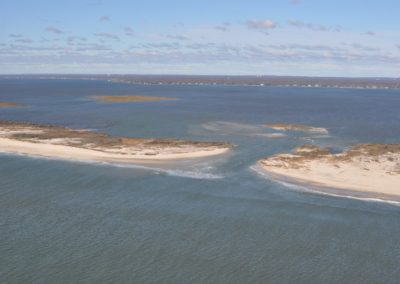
{"left": 0, "top": 74, "right": 400, "bottom": 89}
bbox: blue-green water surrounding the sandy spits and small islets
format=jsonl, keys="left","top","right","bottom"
{"left": 0, "top": 79, "right": 400, "bottom": 283}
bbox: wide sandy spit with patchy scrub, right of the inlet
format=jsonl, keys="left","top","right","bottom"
{"left": 258, "top": 144, "right": 400, "bottom": 199}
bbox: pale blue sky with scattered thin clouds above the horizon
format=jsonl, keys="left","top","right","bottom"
{"left": 0, "top": 0, "right": 400, "bottom": 77}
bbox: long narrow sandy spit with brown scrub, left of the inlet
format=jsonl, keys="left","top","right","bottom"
{"left": 0, "top": 121, "right": 232, "bottom": 163}
